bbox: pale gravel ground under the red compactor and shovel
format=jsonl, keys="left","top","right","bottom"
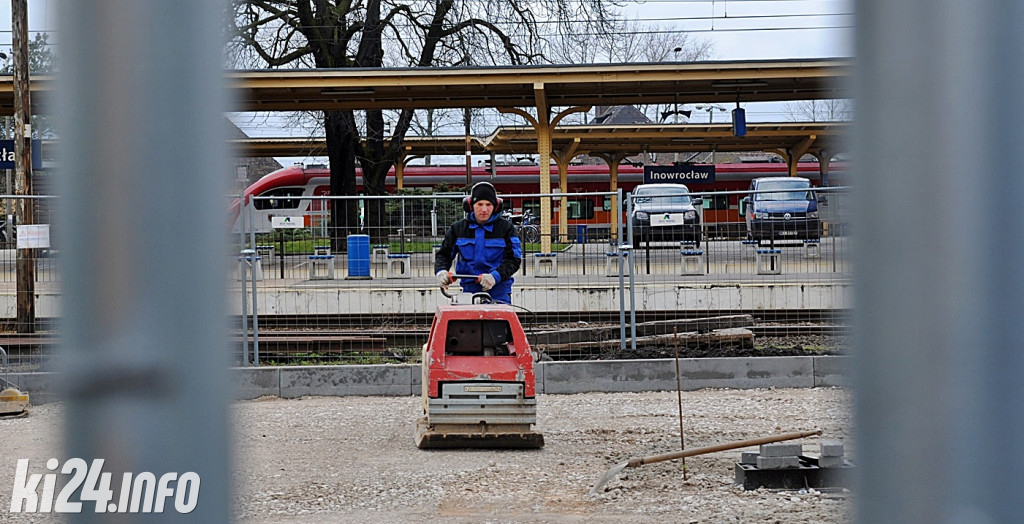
{"left": 0, "top": 389, "right": 853, "bottom": 523}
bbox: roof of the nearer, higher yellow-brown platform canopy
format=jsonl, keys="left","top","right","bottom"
{"left": 0, "top": 58, "right": 852, "bottom": 116}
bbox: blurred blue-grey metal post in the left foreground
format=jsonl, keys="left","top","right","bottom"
{"left": 55, "top": 0, "right": 233, "bottom": 522}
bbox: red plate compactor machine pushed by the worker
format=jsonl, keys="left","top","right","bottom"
{"left": 416, "top": 296, "right": 544, "bottom": 449}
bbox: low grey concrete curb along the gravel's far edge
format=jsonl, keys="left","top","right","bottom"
{"left": 9, "top": 356, "right": 852, "bottom": 404}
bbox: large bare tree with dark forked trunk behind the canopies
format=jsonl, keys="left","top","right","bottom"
{"left": 228, "top": 0, "right": 611, "bottom": 238}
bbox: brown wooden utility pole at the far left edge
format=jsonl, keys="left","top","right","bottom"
{"left": 10, "top": 0, "right": 36, "bottom": 333}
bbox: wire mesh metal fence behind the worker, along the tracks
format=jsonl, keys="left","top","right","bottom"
{"left": 231, "top": 188, "right": 851, "bottom": 362}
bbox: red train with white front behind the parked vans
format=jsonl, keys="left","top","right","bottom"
{"left": 229, "top": 163, "right": 846, "bottom": 232}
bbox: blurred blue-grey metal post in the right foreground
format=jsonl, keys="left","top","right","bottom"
{"left": 854, "top": 0, "right": 1024, "bottom": 523}
